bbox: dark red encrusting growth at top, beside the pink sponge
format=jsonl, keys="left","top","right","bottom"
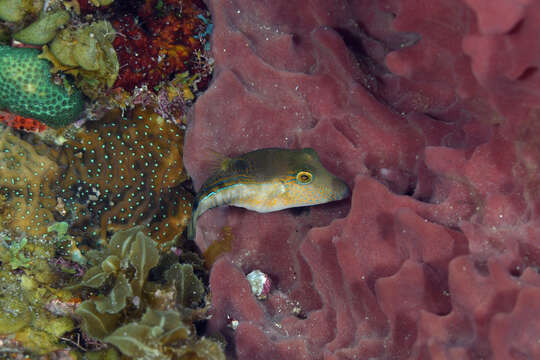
{"left": 112, "top": 0, "right": 208, "bottom": 91}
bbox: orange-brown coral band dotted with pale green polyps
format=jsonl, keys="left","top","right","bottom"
{"left": 0, "top": 101, "right": 193, "bottom": 245}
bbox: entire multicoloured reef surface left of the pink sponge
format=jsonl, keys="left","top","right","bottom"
{"left": 0, "top": 0, "right": 225, "bottom": 360}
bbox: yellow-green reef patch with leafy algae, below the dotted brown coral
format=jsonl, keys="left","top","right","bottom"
{"left": 0, "top": 223, "right": 225, "bottom": 360}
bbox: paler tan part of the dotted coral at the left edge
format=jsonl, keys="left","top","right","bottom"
{"left": 0, "top": 128, "right": 59, "bottom": 235}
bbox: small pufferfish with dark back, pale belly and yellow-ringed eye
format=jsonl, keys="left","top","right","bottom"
{"left": 187, "top": 148, "right": 350, "bottom": 239}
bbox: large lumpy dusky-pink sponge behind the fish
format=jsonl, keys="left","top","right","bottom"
{"left": 184, "top": 0, "right": 540, "bottom": 360}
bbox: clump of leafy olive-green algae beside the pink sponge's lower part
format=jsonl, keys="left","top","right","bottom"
{"left": 71, "top": 226, "right": 225, "bottom": 360}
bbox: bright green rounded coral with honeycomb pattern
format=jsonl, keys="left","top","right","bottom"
{"left": 0, "top": 45, "right": 84, "bottom": 128}
